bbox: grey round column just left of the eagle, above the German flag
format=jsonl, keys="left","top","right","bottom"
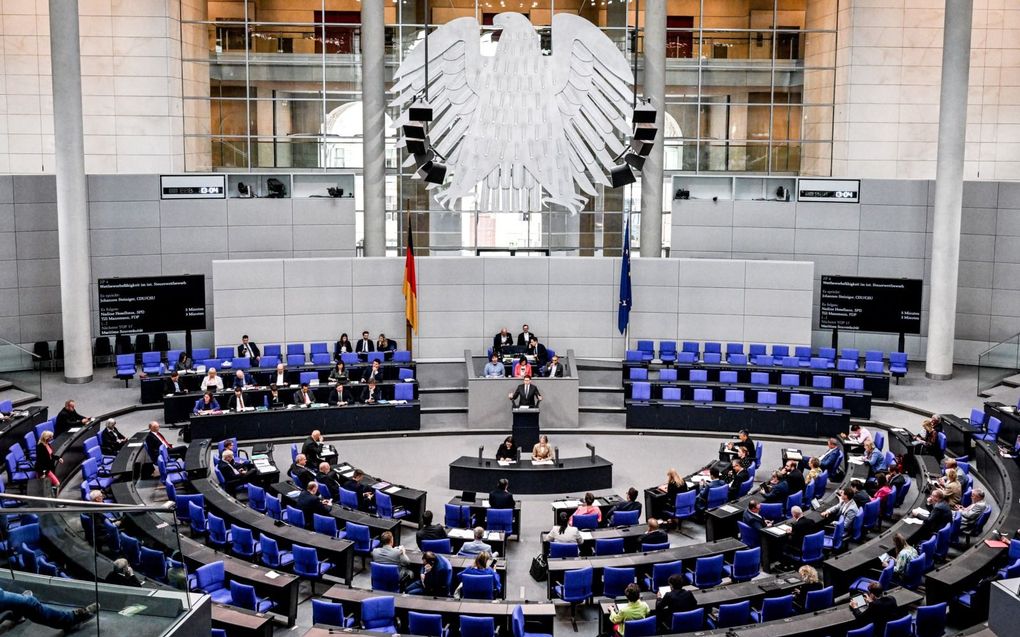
{"left": 361, "top": 0, "right": 386, "bottom": 257}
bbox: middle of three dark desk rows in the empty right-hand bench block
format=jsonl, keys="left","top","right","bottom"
{"left": 623, "top": 380, "right": 871, "bottom": 418}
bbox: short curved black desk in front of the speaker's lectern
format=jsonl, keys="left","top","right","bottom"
{"left": 450, "top": 456, "right": 613, "bottom": 493}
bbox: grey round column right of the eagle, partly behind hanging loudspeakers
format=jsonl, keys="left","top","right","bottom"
{"left": 634, "top": 0, "right": 666, "bottom": 257}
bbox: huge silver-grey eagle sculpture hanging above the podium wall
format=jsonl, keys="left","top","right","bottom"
{"left": 393, "top": 13, "right": 633, "bottom": 213}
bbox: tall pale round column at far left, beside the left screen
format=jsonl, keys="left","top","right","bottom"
{"left": 50, "top": 0, "right": 92, "bottom": 383}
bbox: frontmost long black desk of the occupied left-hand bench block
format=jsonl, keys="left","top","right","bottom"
{"left": 191, "top": 401, "right": 421, "bottom": 440}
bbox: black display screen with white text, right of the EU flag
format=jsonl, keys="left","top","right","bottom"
{"left": 818, "top": 275, "right": 921, "bottom": 334}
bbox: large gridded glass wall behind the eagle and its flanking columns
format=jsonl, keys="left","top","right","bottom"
{"left": 182, "top": 0, "right": 837, "bottom": 254}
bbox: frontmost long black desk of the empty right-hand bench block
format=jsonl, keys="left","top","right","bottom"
{"left": 625, "top": 401, "right": 850, "bottom": 438}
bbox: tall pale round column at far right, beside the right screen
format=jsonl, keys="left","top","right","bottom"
{"left": 924, "top": 0, "right": 974, "bottom": 380}
